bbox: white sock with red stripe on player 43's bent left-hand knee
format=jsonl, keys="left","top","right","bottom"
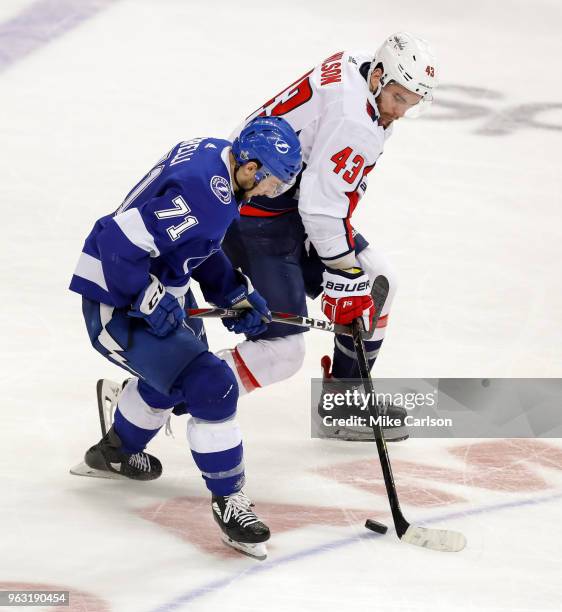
{"left": 219, "top": 334, "right": 305, "bottom": 395}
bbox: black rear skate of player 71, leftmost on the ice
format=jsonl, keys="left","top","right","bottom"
{"left": 80, "top": 427, "right": 162, "bottom": 480}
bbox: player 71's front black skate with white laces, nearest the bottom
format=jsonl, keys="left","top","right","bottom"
{"left": 212, "top": 491, "right": 271, "bottom": 561}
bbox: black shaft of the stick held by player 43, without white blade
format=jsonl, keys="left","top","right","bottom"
{"left": 351, "top": 276, "right": 410, "bottom": 538}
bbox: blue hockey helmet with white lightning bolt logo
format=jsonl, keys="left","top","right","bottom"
{"left": 232, "top": 116, "right": 302, "bottom": 184}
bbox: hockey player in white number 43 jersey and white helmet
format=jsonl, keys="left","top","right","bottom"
{"left": 221, "top": 32, "right": 437, "bottom": 440}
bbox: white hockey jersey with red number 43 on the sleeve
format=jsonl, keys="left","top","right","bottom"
{"left": 243, "top": 52, "right": 391, "bottom": 260}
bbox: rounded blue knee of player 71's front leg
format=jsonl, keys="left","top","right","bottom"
{"left": 178, "top": 352, "right": 238, "bottom": 421}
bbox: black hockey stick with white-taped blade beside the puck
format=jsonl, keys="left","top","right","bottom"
{"left": 351, "top": 276, "right": 466, "bottom": 552}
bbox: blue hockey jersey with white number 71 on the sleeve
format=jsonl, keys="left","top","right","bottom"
{"left": 70, "top": 138, "right": 239, "bottom": 307}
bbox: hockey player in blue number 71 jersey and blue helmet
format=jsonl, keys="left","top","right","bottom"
{"left": 70, "top": 117, "right": 301, "bottom": 557}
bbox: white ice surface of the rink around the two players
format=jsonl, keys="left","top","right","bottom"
{"left": 0, "top": 0, "right": 562, "bottom": 612}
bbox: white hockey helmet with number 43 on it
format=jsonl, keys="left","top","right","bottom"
{"left": 368, "top": 32, "right": 437, "bottom": 116}
